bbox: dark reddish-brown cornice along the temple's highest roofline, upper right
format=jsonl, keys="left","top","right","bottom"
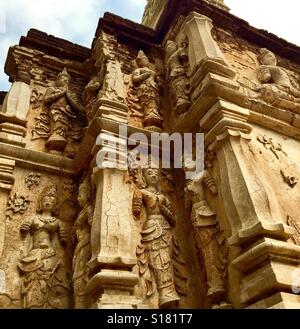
{"left": 93, "top": 0, "right": 300, "bottom": 64}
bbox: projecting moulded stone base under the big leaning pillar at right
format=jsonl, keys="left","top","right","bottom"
{"left": 232, "top": 238, "right": 300, "bottom": 305}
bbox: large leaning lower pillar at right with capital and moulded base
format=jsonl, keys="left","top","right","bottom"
{"left": 200, "top": 101, "right": 300, "bottom": 307}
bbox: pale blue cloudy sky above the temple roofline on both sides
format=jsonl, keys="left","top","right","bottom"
{"left": 0, "top": 0, "right": 300, "bottom": 90}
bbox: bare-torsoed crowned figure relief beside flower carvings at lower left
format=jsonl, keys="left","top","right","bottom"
{"left": 18, "top": 186, "right": 69, "bottom": 309}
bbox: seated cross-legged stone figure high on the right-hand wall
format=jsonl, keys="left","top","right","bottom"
{"left": 257, "top": 48, "right": 300, "bottom": 104}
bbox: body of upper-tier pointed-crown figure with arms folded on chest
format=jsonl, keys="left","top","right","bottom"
{"left": 131, "top": 51, "right": 163, "bottom": 130}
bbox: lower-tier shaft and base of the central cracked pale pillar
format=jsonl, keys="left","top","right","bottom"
{"left": 87, "top": 168, "right": 139, "bottom": 309}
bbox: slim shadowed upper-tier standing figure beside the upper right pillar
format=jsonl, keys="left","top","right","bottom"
{"left": 165, "top": 40, "right": 191, "bottom": 115}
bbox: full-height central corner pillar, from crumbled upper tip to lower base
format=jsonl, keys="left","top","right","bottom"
{"left": 87, "top": 45, "right": 141, "bottom": 309}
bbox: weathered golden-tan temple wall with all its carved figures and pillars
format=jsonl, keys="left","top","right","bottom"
{"left": 0, "top": 0, "right": 300, "bottom": 309}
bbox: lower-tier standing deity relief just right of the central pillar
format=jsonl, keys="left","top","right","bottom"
{"left": 132, "top": 164, "right": 187, "bottom": 308}
